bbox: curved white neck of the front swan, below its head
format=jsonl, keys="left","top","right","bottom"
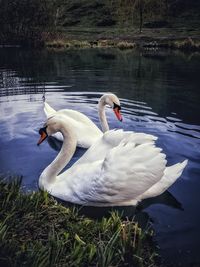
{"left": 39, "top": 126, "right": 77, "bottom": 189}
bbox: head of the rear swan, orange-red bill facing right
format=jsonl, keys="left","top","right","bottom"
{"left": 99, "top": 93, "right": 122, "bottom": 121}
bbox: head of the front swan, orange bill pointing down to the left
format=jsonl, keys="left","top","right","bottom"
{"left": 37, "top": 116, "right": 65, "bottom": 146}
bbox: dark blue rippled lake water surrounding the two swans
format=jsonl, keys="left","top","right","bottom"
{"left": 0, "top": 48, "right": 200, "bottom": 267}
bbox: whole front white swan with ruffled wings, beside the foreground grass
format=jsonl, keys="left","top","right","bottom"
{"left": 38, "top": 115, "right": 187, "bottom": 206}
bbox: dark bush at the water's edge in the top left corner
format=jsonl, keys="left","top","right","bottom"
{"left": 0, "top": 0, "right": 58, "bottom": 45}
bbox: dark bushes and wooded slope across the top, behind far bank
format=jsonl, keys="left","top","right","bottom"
{"left": 0, "top": 0, "right": 200, "bottom": 46}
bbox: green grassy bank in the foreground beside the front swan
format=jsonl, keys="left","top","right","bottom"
{"left": 0, "top": 180, "right": 157, "bottom": 267}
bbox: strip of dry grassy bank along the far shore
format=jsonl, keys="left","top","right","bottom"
{"left": 45, "top": 27, "right": 200, "bottom": 51}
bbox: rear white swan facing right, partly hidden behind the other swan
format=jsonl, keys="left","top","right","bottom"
{"left": 44, "top": 93, "right": 122, "bottom": 148}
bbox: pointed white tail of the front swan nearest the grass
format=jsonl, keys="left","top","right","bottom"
{"left": 140, "top": 160, "right": 188, "bottom": 200}
